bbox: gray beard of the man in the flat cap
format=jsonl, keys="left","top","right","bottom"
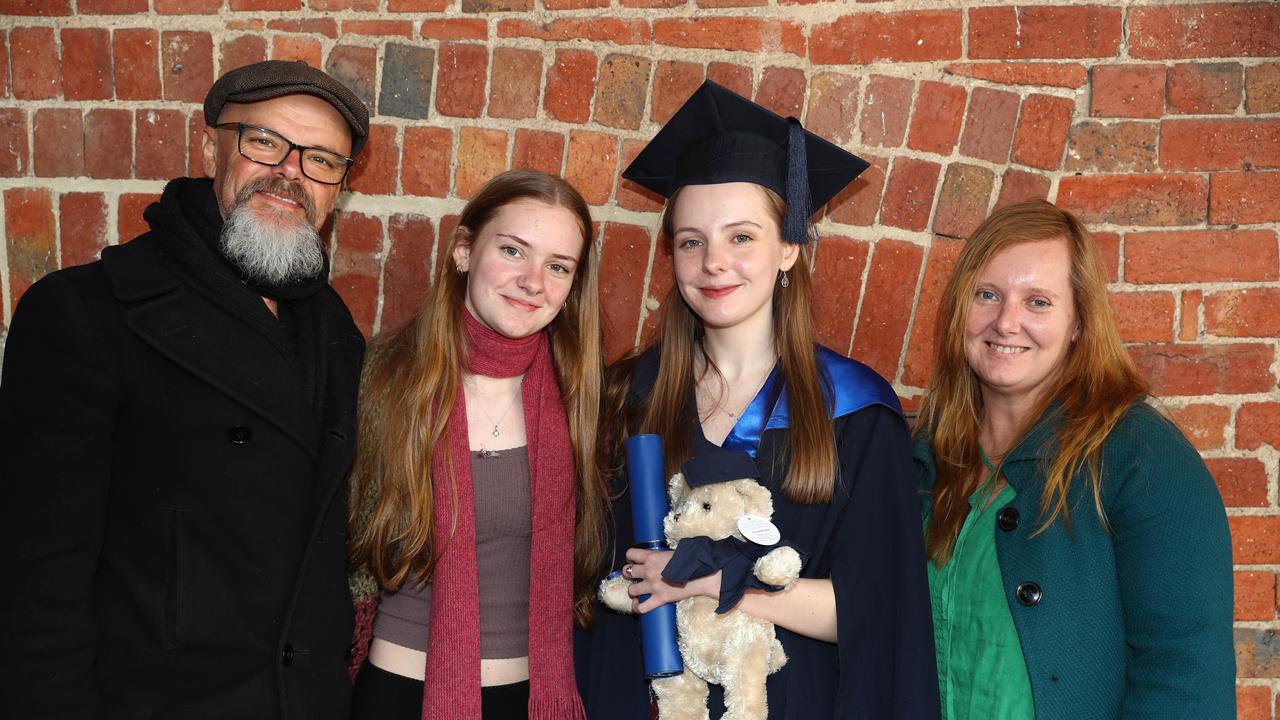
{"left": 219, "top": 202, "right": 324, "bottom": 286}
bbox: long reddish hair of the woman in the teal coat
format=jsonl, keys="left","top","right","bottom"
{"left": 915, "top": 200, "right": 1148, "bottom": 565}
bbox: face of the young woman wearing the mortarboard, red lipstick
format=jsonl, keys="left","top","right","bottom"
{"left": 671, "top": 182, "right": 799, "bottom": 329}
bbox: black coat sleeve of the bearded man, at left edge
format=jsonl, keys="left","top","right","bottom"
{"left": 0, "top": 273, "right": 115, "bottom": 719}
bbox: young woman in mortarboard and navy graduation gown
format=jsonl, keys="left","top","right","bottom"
{"left": 575, "top": 82, "right": 938, "bottom": 720}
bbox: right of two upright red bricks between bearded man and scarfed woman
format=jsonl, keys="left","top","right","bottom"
{"left": 379, "top": 212, "right": 435, "bottom": 332}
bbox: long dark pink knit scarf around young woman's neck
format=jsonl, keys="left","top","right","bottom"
{"left": 422, "top": 310, "right": 586, "bottom": 720}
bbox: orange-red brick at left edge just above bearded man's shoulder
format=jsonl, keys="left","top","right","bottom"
{"left": 4, "top": 187, "right": 58, "bottom": 302}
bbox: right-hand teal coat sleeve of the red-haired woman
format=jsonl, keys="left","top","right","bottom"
{"left": 1103, "top": 407, "right": 1235, "bottom": 720}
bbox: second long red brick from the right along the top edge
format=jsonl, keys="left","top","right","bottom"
{"left": 969, "top": 5, "right": 1124, "bottom": 60}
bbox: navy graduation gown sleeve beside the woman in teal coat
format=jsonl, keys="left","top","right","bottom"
{"left": 831, "top": 405, "right": 940, "bottom": 720}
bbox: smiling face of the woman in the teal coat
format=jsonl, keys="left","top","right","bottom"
{"left": 965, "top": 238, "right": 1079, "bottom": 404}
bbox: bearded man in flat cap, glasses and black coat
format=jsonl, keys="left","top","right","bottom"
{"left": 0, "top": 61, "right": 369, "bottom": 720}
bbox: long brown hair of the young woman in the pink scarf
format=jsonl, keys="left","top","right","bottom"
{"left": 349, "top": 170, "right": 605, "bottom": 623}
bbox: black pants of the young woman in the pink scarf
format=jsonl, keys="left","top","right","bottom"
{"left": 351, "top": 660, "right": 529, "bottom": 720}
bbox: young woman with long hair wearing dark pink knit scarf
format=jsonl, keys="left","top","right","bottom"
{"left": 349, "top": 170, "right": 604, "bottom": 720}
